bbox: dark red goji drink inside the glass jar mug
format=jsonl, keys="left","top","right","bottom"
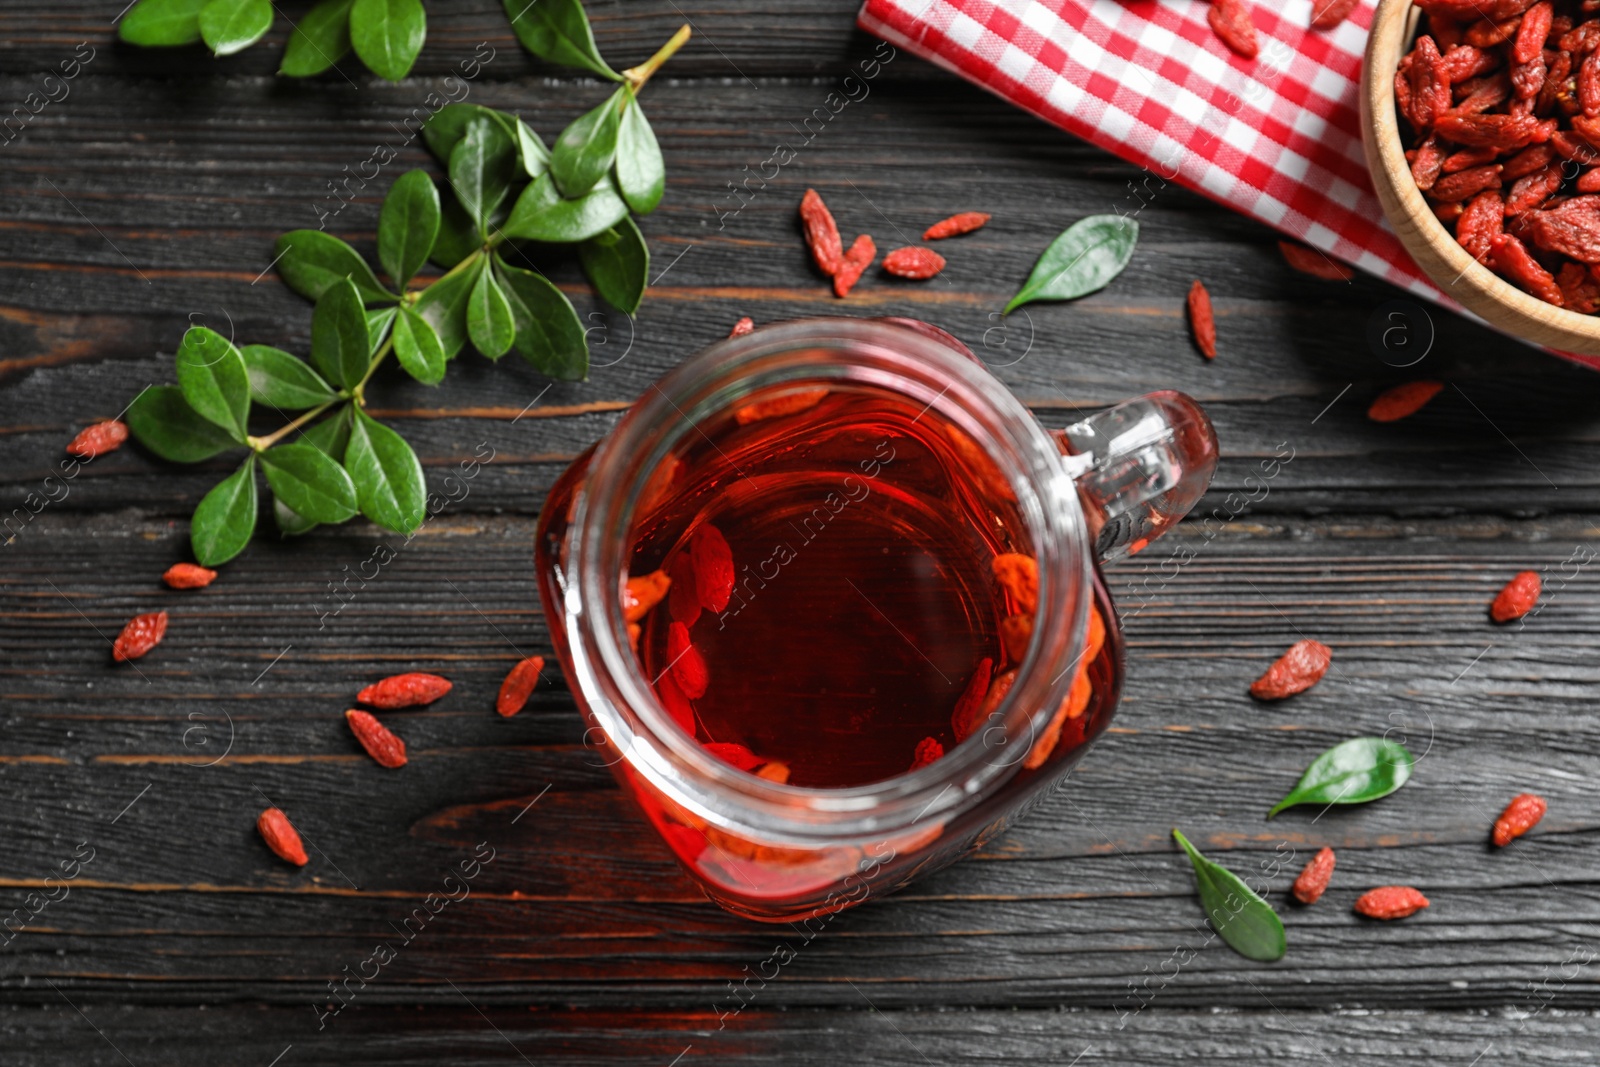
{"left": 629, "top": 387, "right": 1100, "bottom": 787}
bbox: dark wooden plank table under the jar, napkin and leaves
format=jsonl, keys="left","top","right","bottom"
{"left": 0, "top": 0, "right": 1600, "bottom": 1067}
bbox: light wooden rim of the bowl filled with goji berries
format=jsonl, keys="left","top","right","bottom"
{"left": 1362, "top": 0, "right": 1600, "bottom": 355}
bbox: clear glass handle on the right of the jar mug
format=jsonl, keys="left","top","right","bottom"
{"left": 1054, "top": 389, "right": 1218, "bottom": 563}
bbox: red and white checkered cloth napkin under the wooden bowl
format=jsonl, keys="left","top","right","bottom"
{"left": 859, "top": 0, "right": 1600, "bottom": 368}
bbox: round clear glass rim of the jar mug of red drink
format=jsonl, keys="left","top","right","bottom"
{"left": 562, "top": 318, "right": 1093, "bottom": 845}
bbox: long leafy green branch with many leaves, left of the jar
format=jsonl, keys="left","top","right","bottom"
{"left": 116, "top": 10, "right": 688, "bottom": 566}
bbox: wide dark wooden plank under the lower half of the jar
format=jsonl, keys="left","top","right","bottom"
{"left": 0, "top": 510, "right": 1600, "bottom": 1009}
